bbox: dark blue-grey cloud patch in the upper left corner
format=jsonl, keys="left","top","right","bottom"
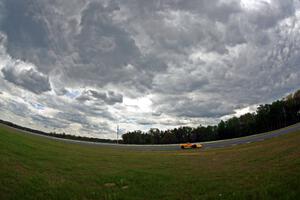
{"left": 0, "top": 0, "right": 55, "bottom": 70}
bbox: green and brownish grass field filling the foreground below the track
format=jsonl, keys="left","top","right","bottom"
{"left": 0, "top": 125, "right": 300, "bottom": 200}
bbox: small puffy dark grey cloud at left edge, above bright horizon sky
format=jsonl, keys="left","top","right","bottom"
{"left": 1, "top": 64, "right": 51, "bottom": 94}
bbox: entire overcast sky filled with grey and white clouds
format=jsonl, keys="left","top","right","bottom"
{"left": 0, "top": 0, "right": 300, "bottom": 138}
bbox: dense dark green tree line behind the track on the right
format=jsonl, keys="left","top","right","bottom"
{"left": 122, "top": 90, "right": 300, "bottom": 144}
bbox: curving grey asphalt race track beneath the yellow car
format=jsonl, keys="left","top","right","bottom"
{"left": 3, "top": 123, "right": 300, "bottom": 151}
